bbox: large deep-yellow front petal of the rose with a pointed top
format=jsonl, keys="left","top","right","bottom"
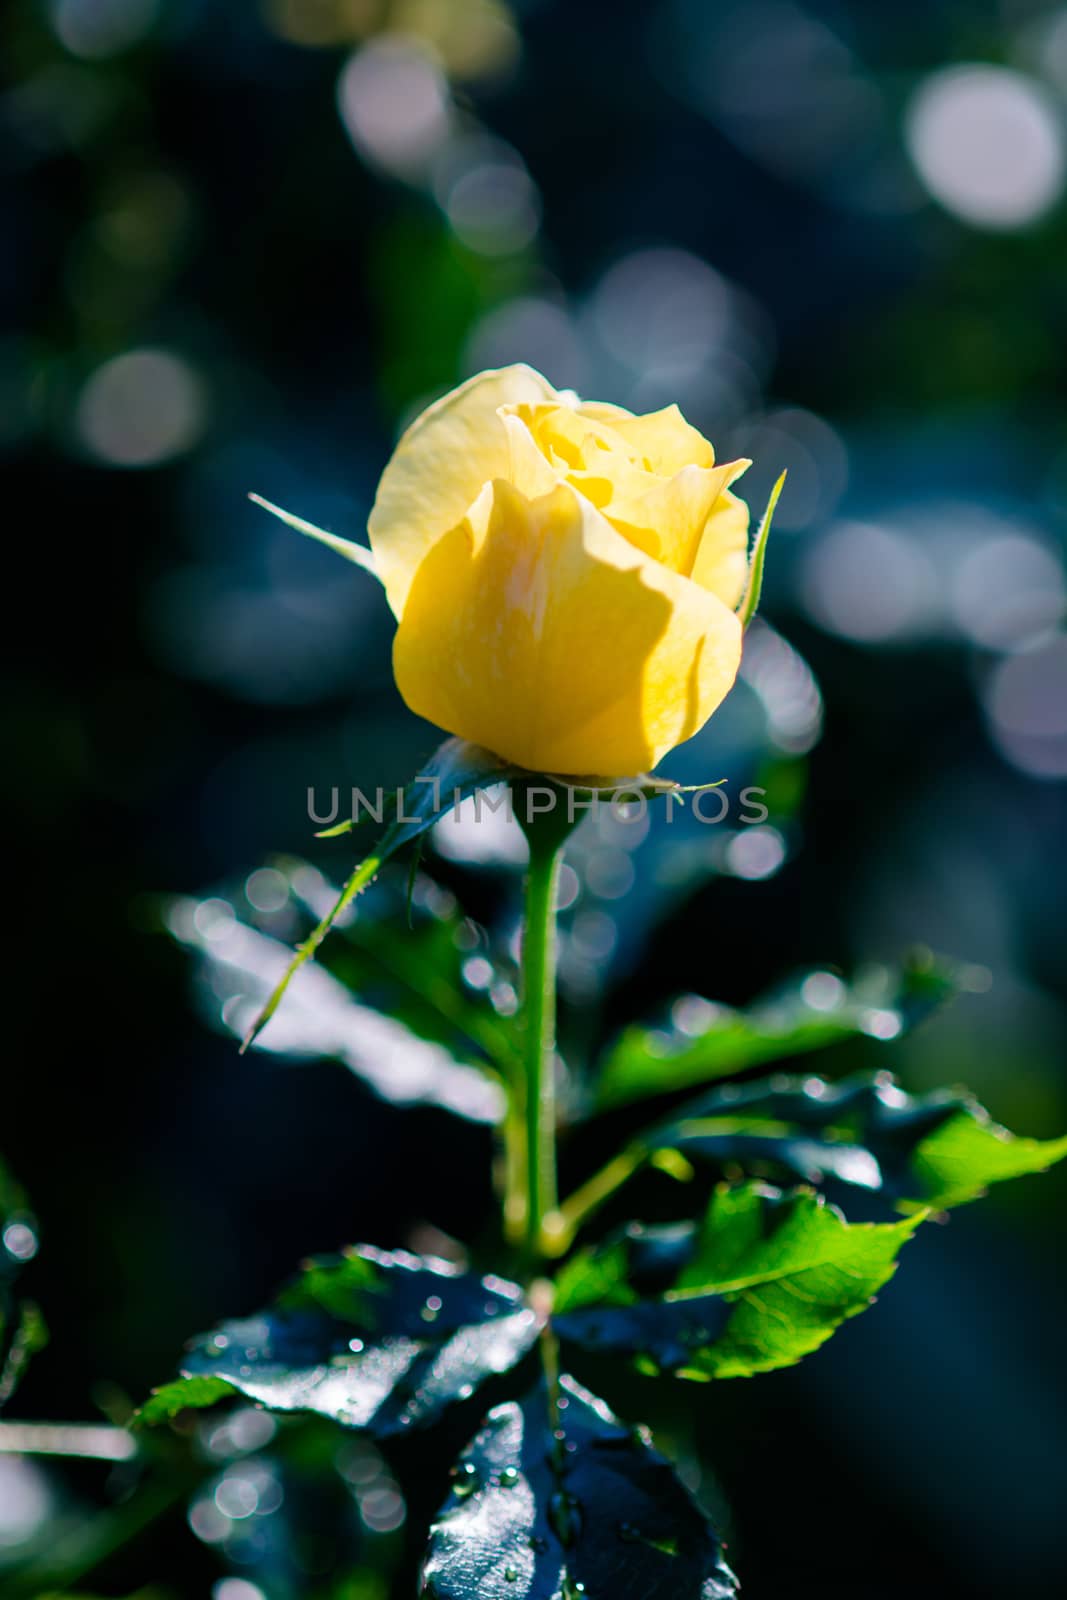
{"left": 394, "top": 482, "right": 741, "bottom": 776}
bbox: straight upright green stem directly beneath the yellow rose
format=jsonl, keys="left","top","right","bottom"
{"left": 522, "top": 827, "right": 563, "bottom": 1259}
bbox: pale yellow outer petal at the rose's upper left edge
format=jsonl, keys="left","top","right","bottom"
{"left": 368, "top": 366, "right": 557, "bottom": 616}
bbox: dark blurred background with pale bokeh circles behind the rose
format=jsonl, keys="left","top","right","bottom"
{"left": 0, "top": 0, "right": 1067, "bottom": 1600}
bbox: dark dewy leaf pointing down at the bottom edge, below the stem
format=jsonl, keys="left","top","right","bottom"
{"left": 422, "top": 1374, "right": 737, "bottom": 1600}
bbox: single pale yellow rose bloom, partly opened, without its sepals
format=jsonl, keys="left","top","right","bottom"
{"left": 370, "top": 366, "right": 749, "bottom": 776}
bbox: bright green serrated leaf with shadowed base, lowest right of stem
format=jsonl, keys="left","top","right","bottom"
{"left": 553, "top": 1184, "right": 921, "bottom": 1379}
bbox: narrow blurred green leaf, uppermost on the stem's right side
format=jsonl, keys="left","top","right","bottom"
{"left": 595, "top": 955, "right": 958, "bottom": 1109}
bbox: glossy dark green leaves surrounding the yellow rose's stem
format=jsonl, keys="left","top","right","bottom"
{"left": 147, "top": 838, "right": 1067, "bottom": 1600}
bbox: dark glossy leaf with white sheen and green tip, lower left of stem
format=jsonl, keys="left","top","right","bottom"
{"left": 141, "top": 1245, "right": 541, "bottom": 1437}
